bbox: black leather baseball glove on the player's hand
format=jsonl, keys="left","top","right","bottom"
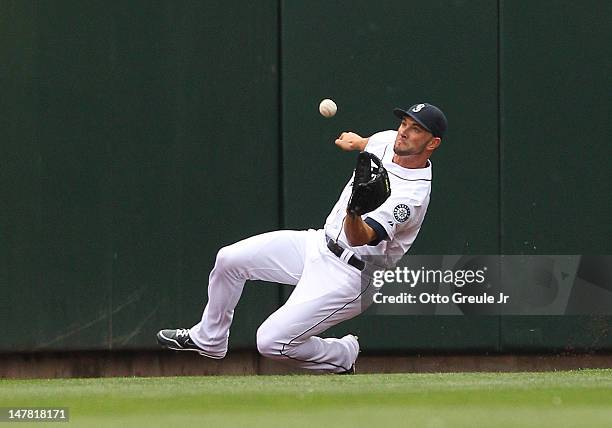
{"left": 348, "top": 152, "right": 391, "bottom": 215}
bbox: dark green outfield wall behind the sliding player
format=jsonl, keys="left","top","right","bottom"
{"left": 0, "top": 0, "right": 612, "bottom": 352}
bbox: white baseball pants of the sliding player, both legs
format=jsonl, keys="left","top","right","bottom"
{"left": 190, "top": 230, "right": 363, "bottom": 372}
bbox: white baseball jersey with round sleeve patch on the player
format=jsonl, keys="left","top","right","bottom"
{"left": 325, "top": 130, "right": 431, "bottom": 267}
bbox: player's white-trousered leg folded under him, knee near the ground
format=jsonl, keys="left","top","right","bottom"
{"left": 257, "top": 232, "right": 370, "bottom": 373}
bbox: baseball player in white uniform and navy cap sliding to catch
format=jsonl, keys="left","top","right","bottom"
{"left": 157, "top": 103, "right": 447, "bottom": 373}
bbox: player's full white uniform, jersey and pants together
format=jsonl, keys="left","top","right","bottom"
{"left": 189, "top": 131, "right": 431, "bottom": 372}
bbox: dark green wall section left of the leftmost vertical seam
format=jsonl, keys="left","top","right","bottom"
{"left": 0, "top": 1, "right": 279, "bottom": 350}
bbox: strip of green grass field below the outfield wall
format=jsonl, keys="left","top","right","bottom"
{"left": 0, "top": 370, "right": 612, "bottom": 428}
